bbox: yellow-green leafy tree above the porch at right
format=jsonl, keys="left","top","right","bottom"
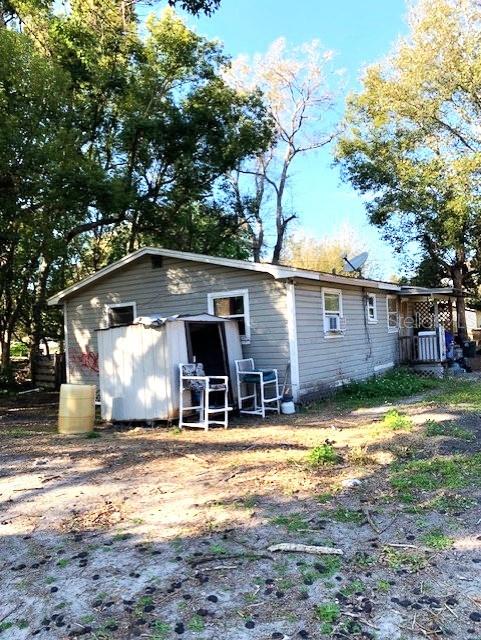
{"left": 337, "top": 0, "right": 481, "bottom": 340}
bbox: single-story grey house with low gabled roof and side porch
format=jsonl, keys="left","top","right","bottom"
{"left": 48, "top": 247, "right": 453, "bottom": 400}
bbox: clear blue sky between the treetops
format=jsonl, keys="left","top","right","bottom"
{"left": 171, "top": 0, "right": 407, "bottom": 277}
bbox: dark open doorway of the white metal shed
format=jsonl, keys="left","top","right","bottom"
{"left": 186, "top": 322, "right": 229, "bottom": 376}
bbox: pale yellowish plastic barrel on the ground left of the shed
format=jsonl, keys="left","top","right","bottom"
{"left": 58, "top": 384, "right": 95, "bottom": 433}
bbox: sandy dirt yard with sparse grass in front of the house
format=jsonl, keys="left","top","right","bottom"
{"left": 0, "top": 394, "right": 481, "bottom": 640}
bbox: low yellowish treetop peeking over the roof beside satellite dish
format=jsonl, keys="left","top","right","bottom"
{"left": 281, "top": 224, "right": 376, "bottom": 277}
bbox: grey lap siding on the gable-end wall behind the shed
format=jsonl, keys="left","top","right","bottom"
{"left": 66, "top": 258, "right": 289, "bottom": 383}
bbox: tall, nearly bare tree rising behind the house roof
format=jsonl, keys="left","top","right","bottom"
{"left": 227, "top": 38, "right": 334, "bottom": 264}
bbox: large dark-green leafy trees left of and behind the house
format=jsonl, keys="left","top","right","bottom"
{"left": 0, "top": 0, "right": 270, "bottom": 378}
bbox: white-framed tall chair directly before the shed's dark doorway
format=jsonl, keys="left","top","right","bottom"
{"left": 179, "top": 362, "right": 232, "bottom": 431}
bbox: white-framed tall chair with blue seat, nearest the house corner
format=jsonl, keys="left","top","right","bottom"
{"left": 235, "top": 358, "right": 281, "bottom": 418}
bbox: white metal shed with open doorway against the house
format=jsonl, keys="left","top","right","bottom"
{"left": 97, "top": 314, "right": 242, "bottom": 421}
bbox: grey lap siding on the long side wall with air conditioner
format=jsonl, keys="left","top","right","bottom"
{"left": 296, "top": 283, "right": 398, "bottom": 395}
